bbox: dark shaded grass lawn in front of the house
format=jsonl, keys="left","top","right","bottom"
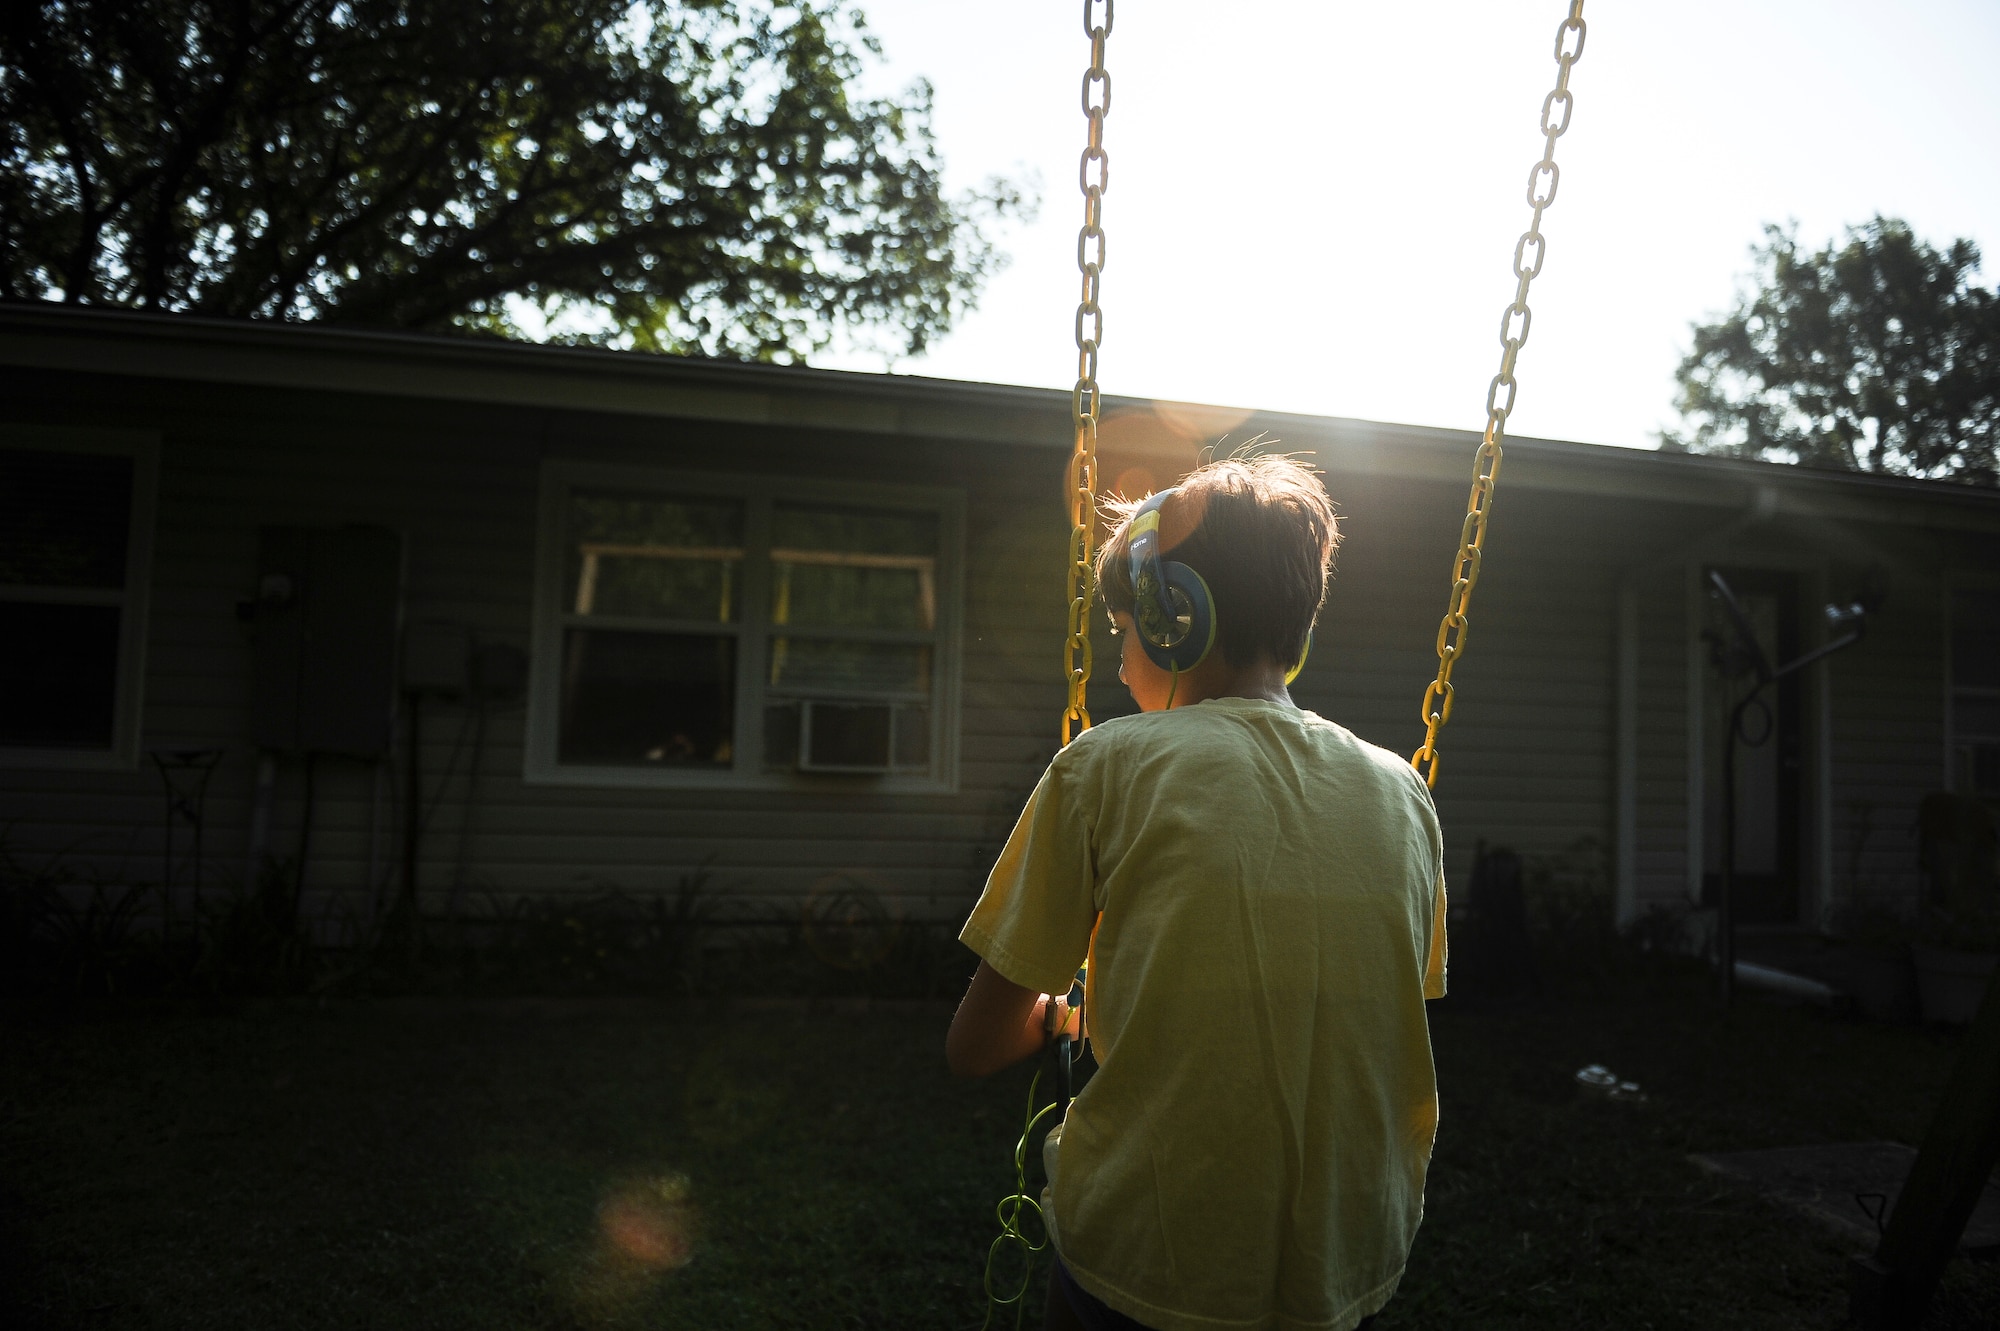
{"left": 0, "top": 981, "right": 2000, "bottom": 1331}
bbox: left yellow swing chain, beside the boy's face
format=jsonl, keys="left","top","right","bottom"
{"left": 1062, "top": 0, "right": 1112, "bottom": 743}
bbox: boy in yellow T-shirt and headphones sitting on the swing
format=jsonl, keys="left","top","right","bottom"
{"left": 946, "top": 456, "right": 1444, "bottom": 1331}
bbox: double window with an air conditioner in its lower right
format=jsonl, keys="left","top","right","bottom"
{"left": 526, "top": 462, "right": 960, "bottom": 789}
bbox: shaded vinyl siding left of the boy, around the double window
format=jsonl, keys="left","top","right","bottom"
{"left": 0, "top": 373, "right": 1062, "bottom": 921}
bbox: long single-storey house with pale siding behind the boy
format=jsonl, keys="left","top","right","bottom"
{"left": 0, "top": 304, "right": 2000, "bottom": 943}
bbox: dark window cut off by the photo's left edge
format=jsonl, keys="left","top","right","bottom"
{"left": 0, "top": 426, "right": 154, "bottom": 767}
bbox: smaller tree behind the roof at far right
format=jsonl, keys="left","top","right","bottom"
{"left": 1660, "top": 216, "right": 2000, "bottom": 486}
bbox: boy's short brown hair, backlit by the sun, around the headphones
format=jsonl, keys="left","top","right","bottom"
{"left": 1098, "top": 454, "right": 1340, "bottom": 666}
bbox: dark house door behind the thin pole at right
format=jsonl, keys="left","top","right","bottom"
{"left": 1702, "top": 568, "right": 1804, "bottom": 925}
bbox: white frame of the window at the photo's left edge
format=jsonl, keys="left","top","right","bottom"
{"left": 0, "top": 424, "right": 160, "bottom": 771}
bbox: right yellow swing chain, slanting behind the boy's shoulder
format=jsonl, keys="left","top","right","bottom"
{"left": 1410, "top": 0, "right": 1584, "bottom": 789}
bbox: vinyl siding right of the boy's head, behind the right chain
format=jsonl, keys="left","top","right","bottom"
{"left": 1294, "top": 472, "right": 1678, "bottom": 883}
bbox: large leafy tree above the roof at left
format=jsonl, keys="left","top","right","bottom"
{"left": 0, "top": 0, "right": 1022, "bottom": 360}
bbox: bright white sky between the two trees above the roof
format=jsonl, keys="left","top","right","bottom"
{"left": 816, "top": 0, "right": 2000, "bottom": 448}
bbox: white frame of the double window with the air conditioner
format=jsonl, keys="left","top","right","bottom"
{"left": 522, "top": 458, "right": 966, "bottom": 795}
